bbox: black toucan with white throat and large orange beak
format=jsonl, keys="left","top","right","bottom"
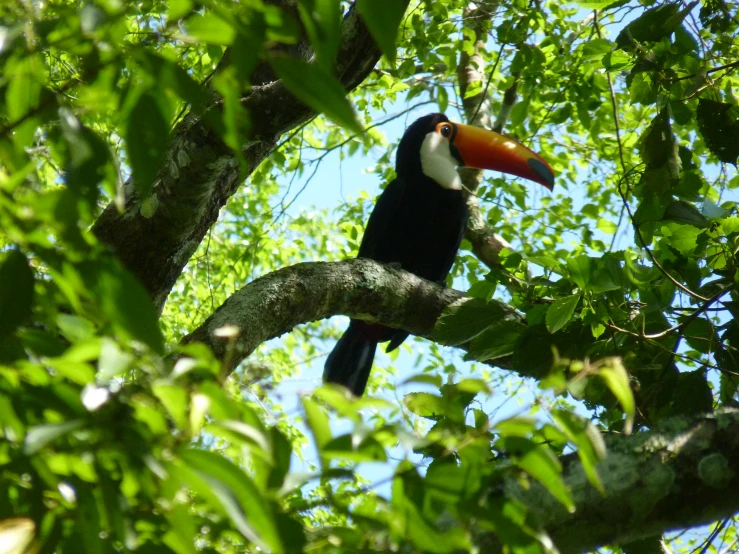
{"left": 323, "top": 113, "right": 554, "bottom": 396}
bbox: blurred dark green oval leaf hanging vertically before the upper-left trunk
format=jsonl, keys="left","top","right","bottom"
{"left": 126, "top": 92, "right": 169, "bottom": 194}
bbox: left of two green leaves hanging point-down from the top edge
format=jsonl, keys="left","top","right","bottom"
{"left": 298, "top": 0, "right": 341, "bottom": 71}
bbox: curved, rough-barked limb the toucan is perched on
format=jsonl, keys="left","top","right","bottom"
{"left": 183, "top": 258, "right": 523, "bottom": 372}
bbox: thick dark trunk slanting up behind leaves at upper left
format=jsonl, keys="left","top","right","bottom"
{"left": 94, "top": 5, "right": 407, "bottom": 310}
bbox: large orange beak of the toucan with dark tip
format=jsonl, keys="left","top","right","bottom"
{"left": 453, "top": 123, "right": 554, "bottom": 190}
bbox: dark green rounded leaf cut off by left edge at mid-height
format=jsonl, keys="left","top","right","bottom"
{"left": 0, "top": 250, "right": 34, "bottom": 339}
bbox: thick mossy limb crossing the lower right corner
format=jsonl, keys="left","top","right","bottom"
{"left": 481, "top": 409, "right": 739, "bottom": 554}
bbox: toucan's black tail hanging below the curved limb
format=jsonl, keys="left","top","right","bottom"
{"left": 323, "top": 320, "right": 377, "bottom": 396}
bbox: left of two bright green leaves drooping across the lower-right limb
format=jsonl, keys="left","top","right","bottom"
{"left": 497, "top": 436, "right": 575, "bottom": 513}
